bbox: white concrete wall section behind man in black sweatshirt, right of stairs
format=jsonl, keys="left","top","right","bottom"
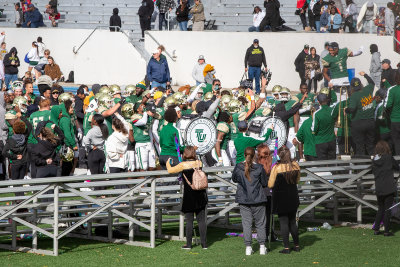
{"left": 145, "top": 32, "right": 399, "bottom": 90}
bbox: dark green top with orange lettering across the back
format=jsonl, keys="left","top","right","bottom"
{"left": 346, "top": 84, "right": 375, "bottom": 121}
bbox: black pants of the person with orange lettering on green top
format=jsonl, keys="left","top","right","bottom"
{"left": 351, "top": 119, "right": 375, "bottom": 156}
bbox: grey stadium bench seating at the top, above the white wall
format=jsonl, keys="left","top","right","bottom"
{"left": 0, "top": 0, "right": 394, "bottom": 37}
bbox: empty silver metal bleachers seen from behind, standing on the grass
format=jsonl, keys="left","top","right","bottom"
{"left": 0, "top": 159, "right": 392, "bottom": 256}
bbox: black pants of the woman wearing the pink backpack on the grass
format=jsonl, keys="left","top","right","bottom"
{"left": 185, "top": 208, "right": 207, "bottom": 247}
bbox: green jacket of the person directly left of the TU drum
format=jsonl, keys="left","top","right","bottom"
{"left": 160, "top": 123, "right": 184, "bottom": 157}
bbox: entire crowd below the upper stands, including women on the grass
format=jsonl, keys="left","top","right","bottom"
{"left": 0, "top": 25, "right": 400, "bottom": 255}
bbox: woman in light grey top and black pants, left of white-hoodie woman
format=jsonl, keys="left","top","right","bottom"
{"left": 82, "top": 114, "right": 108, "bottom": 174}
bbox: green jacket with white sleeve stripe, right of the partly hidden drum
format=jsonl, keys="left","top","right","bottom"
{"left": 311, "top": 105, "right": 337, "bottom": 144}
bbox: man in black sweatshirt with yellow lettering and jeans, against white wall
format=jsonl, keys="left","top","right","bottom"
{"left": 244, "top": 39, "right": 267, "bottom": 94}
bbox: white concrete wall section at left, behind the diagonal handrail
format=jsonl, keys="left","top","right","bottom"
{"left": 0, "top": 28, "right": 146, "bottom": 84}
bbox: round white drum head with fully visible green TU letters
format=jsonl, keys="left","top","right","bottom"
{"left": 185, "top": 117, "right": 217, "bottom": 155}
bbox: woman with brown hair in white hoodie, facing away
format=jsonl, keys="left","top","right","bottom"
{"left": 106, "top": 113, "right": 129, "bottom": 173}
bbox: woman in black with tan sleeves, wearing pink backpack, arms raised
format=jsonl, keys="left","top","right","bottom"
{"left": 167, "top": 146, "right": 208, "bottom": 249}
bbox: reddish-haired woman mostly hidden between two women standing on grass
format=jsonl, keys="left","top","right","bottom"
{"left": 257, "top": 144, "right": 276, "bottom": 241}
